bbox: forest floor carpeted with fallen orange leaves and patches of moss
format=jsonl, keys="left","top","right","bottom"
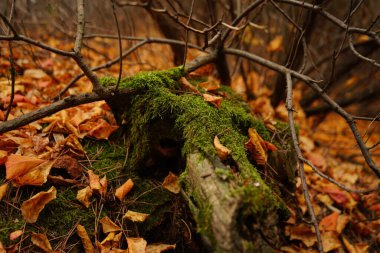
{"left": 0, "top": 34, "right": 380, "bottom": 253}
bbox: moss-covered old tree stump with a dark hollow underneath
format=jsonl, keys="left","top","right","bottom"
{"left": 102, "top": 68, "right": 294, "bottom": 252}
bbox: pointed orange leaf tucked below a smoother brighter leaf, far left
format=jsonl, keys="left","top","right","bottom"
{"left": 13, "top": 161, "right": 54, "bottom": 186}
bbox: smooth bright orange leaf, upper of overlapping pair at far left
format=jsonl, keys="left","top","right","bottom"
{"left": 5, "top": 154, "right": 45, "bottom": 180}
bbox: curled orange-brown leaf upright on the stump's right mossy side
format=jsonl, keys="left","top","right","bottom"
{"left": 245, "top": 128, "right": 267, "bottom": 165}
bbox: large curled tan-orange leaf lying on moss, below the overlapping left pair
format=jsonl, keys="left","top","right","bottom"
{"left": 21, "top": 186, "right": 57, "bottom": 223}
